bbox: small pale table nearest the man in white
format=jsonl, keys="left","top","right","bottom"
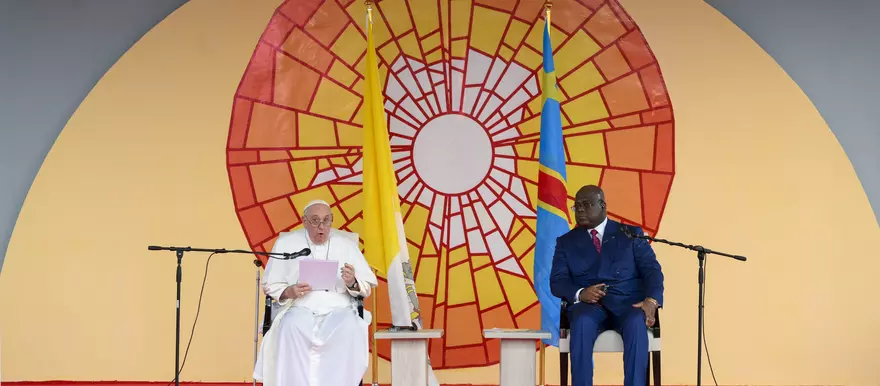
{"left": 373, "top": 330, "right": 443, "bottom": 386}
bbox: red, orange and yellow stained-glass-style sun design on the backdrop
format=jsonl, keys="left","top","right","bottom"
{"left": 227, "top": 0, "right": 674, "bottom": 369}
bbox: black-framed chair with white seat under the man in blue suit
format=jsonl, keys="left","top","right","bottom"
{"left": 559, "top": 300, "right": 660, "bottom": 386}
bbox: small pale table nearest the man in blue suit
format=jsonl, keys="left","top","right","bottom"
{"left": 483, "top": 329, "right": 550, "bottom": 386}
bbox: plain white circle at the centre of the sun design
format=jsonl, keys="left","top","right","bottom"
{"left": 413, "top": 114, "right": 492, "bottom": 194}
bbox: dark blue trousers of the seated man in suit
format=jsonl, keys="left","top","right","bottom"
{"left": 568, "top": 303, "right": 648, "bottom": 386}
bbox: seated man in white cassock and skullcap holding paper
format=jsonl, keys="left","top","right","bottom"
{"left": 254, "top": 200, "right": 378, "bottom": 386}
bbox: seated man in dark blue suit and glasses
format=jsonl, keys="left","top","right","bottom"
{"left": 550, "top": 185, "right": 663, "bottom": 386}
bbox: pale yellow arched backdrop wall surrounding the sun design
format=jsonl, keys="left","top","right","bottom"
{"left": 0, "top": 0, "right": 880, "bottom": 385}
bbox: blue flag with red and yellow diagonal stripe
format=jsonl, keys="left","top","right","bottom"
{"left": 534, "top": 12, "right": 569, "bottom": 346}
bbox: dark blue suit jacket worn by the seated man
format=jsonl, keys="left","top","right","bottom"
{"left": 550, "top": 219, "right": 663, "bottom": 316}
